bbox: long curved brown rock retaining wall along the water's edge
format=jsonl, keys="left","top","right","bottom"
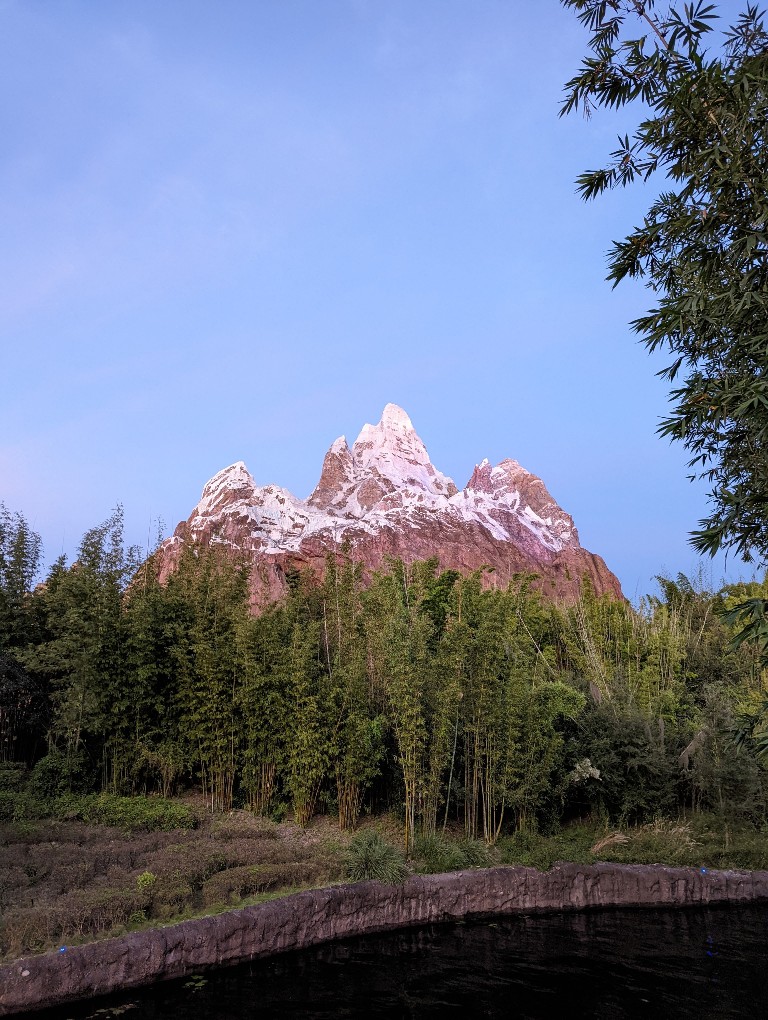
{"left": 0, "top": 864, "right": 768, "bottom": 1015}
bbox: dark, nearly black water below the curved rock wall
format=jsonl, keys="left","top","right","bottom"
{"left": 29, "top": 907, "right": 768, "bottom": 1020}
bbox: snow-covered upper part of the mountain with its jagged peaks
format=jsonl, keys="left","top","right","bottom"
{"left": 178, "top": 404, "right": 578, "bottom": 552}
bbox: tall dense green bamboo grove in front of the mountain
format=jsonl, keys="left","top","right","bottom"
{"left": 0, "top": 501, "right": 768, "bottom": 847}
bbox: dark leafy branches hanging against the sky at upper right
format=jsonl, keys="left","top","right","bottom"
{"left": 562, "top": 0, "right": 768, "bottom": 559}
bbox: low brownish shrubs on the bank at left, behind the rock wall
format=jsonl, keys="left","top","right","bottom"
{"left": 0, "top": 800, "right": 340, "bottom": 957}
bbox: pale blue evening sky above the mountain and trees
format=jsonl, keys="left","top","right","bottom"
{"left": 0, "top": 0, "right": 751, "bottom": 599}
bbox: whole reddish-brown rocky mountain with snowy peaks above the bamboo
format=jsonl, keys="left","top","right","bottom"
{"left": 157, "top": 404, "right": 622, "bottom": 610}
